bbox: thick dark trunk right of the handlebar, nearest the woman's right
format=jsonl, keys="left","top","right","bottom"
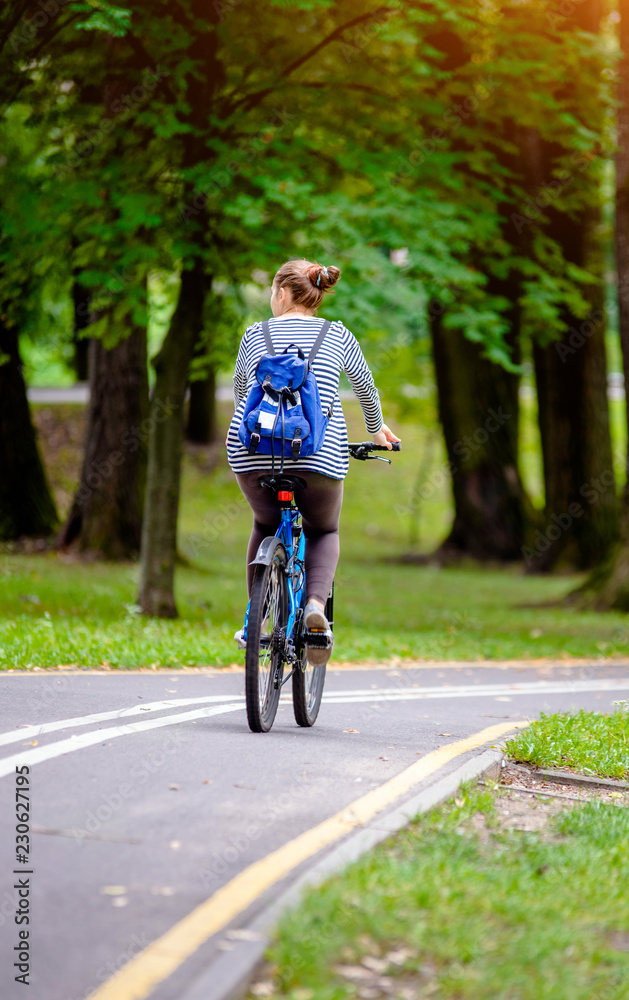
{"left": 430, "top": 303, "right": 528, "bottom": 562}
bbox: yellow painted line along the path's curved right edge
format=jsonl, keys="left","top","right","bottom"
{"left": 87, "top": 722, "right": 529, "bottom": 1000}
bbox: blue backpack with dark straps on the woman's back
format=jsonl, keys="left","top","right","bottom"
{"left": 238, "top": 320, "right": 332, "bottom": 467}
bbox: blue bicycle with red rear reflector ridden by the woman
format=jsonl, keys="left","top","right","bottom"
{"left": 241, "top": 441, "right": 401, "bottom": 733}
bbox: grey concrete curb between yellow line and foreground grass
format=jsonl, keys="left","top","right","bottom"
{"left": 180, "top": 750, "right": 502, "bottom": 1000}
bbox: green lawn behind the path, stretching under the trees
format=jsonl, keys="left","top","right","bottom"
{"left": 0, "top": 402, "right": 629, "bottom": 669}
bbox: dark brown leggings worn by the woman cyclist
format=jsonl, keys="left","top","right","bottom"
{"left": 236, "top": 470, "right": 343, "bottom": 604}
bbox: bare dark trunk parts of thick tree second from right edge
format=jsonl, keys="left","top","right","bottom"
{"left": 517, "top": 0, "right": 619, "bottom": 572}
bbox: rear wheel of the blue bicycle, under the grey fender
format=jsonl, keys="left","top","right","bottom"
{"left": 245, "top": 541, "right": 288, "bottom": 733}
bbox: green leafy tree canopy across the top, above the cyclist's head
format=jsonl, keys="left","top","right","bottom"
{"left": 0, "top": 0, "right": 610, "bottom": 376}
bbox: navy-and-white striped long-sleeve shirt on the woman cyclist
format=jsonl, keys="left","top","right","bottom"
{"left": 227, "top": 316, "right": 383, "bottom": 479}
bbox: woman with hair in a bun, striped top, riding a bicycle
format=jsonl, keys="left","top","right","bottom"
{"left": 226, "top": 260, "right": 400, "bottom": 666}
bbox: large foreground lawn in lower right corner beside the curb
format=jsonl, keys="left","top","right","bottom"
{"left": 262, "top": 791, "right": 629, "bottom": 1000}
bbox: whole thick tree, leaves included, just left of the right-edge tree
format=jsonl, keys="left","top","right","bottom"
{"left": 514, "top": 0, "right": 618, "bottom": 571}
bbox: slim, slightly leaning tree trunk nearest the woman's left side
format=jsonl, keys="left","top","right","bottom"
{"left": 138, "top": 258, "right": 211, "bottom": 618}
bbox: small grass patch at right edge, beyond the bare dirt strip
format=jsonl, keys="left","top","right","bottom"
{"left": 506, "top": 701, "right": 629, "bottom": 778}
